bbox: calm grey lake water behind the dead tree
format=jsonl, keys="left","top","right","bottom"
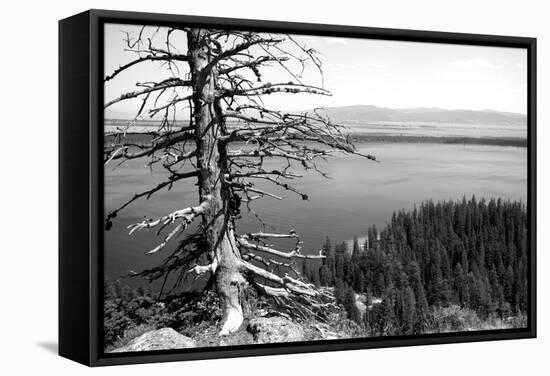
{"left": 105, "top": 143, "right": 527, "bottom": 277}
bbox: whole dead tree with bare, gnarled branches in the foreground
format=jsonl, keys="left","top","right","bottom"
{"left": 104, "top": 27, "right": 375, "bottom": 334}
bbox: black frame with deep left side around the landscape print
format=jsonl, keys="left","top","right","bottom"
{"left": 59, "top": 10, "right": 537, "bottom": 366}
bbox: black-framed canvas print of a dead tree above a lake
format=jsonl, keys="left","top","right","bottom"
{"left": 59, "top": 10, "right": 536, "bottom": 366}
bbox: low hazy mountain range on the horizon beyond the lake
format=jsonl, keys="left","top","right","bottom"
{"left": 310, "top": 105, "right": 527, "bottom": 126}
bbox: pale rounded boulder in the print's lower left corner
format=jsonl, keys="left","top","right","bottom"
{"left": 111, "top": 328, "right": 196, "bottom": 353}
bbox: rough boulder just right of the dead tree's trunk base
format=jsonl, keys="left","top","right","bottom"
{"left": 246, "top": 317, "right": 304, "bottom": 343}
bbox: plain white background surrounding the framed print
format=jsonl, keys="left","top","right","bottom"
{"left": 0, "top": 0, "right": 550, "bottom": 376}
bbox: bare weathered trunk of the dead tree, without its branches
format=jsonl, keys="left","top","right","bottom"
{"left": 187, "top": 29, "right": 246, "bottom": 334}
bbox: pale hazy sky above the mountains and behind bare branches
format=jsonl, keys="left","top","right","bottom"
{"left": 105, "top": 24, "right": 527, "bottom": 118}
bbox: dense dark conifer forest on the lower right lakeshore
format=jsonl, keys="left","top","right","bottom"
{"left": 303, "top": 197, "right": 528, "bottom": 335}
